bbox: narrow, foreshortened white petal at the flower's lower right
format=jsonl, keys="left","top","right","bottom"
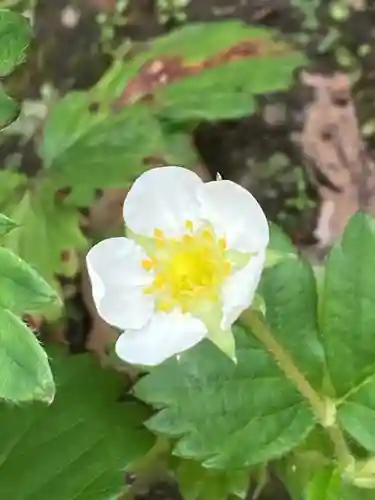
{"left": 221, "top": 251, "right": 266, "bottom": 329}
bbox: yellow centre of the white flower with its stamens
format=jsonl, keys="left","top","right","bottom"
{"left": 142, "top": 221, "right": 231, "bottom": 311}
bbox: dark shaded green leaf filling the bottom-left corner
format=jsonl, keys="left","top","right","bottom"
{"left": 0, "top": 351, "right": 153, "bottom": 500}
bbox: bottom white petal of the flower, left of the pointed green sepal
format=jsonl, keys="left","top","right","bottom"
{"left": 116, "top": 310, "right": 207, "bottom": 366}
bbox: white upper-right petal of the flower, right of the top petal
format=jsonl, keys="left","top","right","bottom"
{"left": 197, "top": 180, "right": 269, "bottom": 252}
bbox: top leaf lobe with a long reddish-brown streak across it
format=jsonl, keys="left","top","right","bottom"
{"left": 116, "top": 21, "right": 303, "bottom": 120}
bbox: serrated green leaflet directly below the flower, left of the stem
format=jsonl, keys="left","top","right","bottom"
{"left": 136, "top": 328, "right": 314, "bottom": 469}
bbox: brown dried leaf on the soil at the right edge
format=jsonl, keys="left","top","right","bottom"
{"left": 300, "top": 72, "right": 375, "bottom": 247}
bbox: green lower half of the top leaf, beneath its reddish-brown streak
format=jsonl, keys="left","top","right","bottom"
{"left": 155, "top": 53, "right": 302, "bottom": 121}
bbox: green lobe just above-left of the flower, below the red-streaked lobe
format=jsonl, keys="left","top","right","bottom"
{"left": 39, "top": 94, "right": 198, "bottom": 197}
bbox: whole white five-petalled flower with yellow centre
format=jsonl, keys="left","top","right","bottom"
{"left": 87, "top": 167, "right": 269, "bottom": 365}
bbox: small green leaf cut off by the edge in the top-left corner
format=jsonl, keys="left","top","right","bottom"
{"left": 0, "top": 9, "right": 31, "bottom": 77}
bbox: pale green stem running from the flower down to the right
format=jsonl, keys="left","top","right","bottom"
{"left": 241, "top": 309, "right": 353, "bottom": 469}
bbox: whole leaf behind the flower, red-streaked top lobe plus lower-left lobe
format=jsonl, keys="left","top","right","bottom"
{"left": 39, "top": 21, "right": 302, "bottom": 196}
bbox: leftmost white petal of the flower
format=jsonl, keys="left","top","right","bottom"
{"left": 86, "top": 238, "right": 154, "bottom": 329}
